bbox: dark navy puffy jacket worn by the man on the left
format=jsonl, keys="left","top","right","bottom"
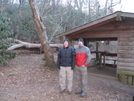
{"left": 57, "top": 46, "right": 75, "bottom": 70}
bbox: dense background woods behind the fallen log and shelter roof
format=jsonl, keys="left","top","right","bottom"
{"left": 0, "top": 0, "right": 121, "bottom": 66}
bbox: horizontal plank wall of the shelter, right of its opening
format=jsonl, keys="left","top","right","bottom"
{"left": 117, "top": 32, "right": 134, "bottom": 85}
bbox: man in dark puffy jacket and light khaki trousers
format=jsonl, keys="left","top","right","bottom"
{"left": 57, "top": 39, "right": 75, "bottom": 94}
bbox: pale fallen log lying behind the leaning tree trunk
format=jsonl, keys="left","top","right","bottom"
{"left": 6, "top": 40, "right": 63, "bottom": 52}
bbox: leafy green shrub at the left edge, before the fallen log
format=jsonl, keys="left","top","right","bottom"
{"left": 0, "top": 13, "right": 17, "bottom": 65}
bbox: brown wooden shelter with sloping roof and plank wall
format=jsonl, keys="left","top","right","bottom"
{"left": 56, "top": 11, "right": 134, "bottom": 85}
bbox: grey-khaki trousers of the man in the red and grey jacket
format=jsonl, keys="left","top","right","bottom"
{"left": 75, "top": 65, "right": 87, "bottom": 93}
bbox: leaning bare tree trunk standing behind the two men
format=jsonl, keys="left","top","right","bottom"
{"left": 29, "top": 0, "right": 56, "bottom": 68}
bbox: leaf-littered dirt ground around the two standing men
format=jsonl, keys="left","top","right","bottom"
{"left": 0, "top": 53, "right": 134, "bottom": 101}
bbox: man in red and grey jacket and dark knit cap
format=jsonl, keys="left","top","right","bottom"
{"left": 75, "top": 38, "right": 91, "bottom": 97}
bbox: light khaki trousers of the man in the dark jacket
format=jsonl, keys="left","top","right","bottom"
{"left": 59, "top": 66, "right": 73, "bottom": 91}
